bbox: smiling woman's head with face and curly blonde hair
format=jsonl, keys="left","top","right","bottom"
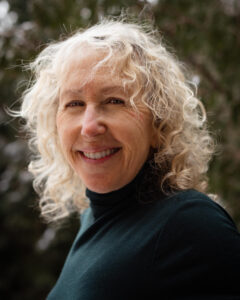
{"left": 18, "top": 21, "right": 213, "bottom": 219}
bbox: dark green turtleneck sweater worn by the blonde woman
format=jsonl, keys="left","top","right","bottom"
{"left": 47, "top": 170, "right": 240, "bottom": 300}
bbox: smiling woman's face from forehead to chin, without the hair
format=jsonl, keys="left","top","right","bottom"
{"left": 56, "top": 49, "right": 157, "bottom": 193}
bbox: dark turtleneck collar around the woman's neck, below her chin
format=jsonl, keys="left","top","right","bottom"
{"left": 86, "top": 163, "right": 154, "bottom": 218}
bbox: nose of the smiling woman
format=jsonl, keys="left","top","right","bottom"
{"left": 81, "top": 106, "right": 106, "bottom": 137}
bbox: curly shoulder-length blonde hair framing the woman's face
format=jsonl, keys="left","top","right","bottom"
{"left": 18, "top": 20, "right": 214, "bottom": 221}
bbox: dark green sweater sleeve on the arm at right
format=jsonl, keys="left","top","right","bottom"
{"left": 153, "top": 195, "right": 240, "bottom": 299}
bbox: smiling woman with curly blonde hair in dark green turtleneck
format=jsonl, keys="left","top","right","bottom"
{"left": 18, "top": 21, "right": 240, "bottom": 300}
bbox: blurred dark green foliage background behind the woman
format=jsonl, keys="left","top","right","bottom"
{"left": 0, "top": 0, "right": 240, "bottom": 300}
